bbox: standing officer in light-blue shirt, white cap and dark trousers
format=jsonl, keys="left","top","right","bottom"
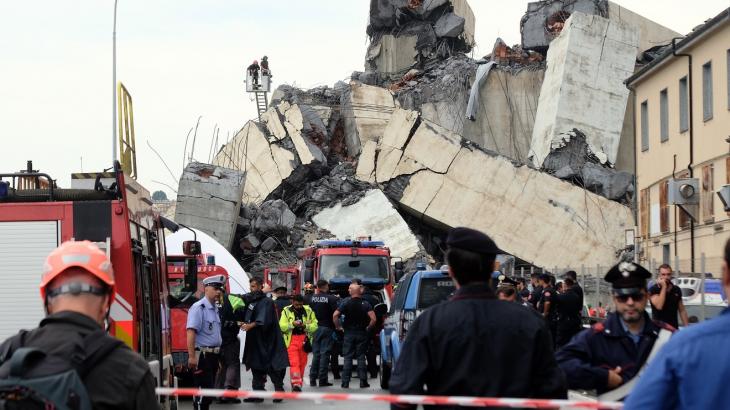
{"left": 187, "top": 275, "right": 225, "bottom": 410}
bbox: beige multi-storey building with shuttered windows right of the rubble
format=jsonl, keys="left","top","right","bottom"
{"left": 626, "top": 8, "right": 730, "bottom": 277}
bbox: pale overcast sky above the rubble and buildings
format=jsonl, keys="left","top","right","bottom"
{"left": 0, "top": 0, "right": 730, "bottom": 198}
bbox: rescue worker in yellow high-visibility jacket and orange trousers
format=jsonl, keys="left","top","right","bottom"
{"left": 279, "top": 295, "right": 317, "bottom": 392}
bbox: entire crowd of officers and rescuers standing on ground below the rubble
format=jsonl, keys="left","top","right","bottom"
{"left": 0, "top": 228, "right": 730, "bottom": 409}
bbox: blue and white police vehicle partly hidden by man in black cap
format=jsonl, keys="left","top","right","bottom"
{"left": 380, "top": 270, "right": 455, "bottom": 389}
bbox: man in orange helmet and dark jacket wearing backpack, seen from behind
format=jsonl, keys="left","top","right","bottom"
{"left": 0, "top": 241, "right": 159, "bottom": 410}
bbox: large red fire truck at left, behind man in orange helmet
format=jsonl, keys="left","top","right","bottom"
{"left": 0, "top": 163, "right": 191, "bottom": 408}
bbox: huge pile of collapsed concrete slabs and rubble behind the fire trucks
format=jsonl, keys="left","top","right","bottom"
{"left": 172, "top": 0, "right": 684, "bottom": 273}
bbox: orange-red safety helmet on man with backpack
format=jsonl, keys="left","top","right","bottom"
{"left": 40, "top": 241, "right": 115, "bottom": 301}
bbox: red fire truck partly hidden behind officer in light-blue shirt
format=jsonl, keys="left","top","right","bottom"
{"left": 167, "top": 254, "right": 230, "bottom": 386}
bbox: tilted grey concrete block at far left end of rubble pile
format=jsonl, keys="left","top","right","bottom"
{"left": 175, "top": 162, "right": 244, "bottom": 250}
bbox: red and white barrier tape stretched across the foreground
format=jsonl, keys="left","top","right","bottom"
{"left": 156, "top": 387, "right": 623, "bottom": 409}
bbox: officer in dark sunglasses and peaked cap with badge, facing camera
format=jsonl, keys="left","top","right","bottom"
{"left": 557, "top": 262, "right": 671, "bottom": 394}
